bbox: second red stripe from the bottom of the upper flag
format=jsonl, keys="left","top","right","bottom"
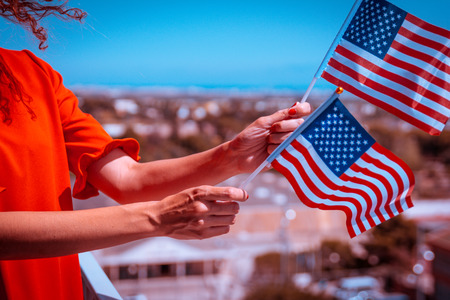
{"left": 328, "top": 55, "right": 448, "bottom": 124}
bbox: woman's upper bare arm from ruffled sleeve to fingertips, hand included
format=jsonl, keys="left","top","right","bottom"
{"left": 88, "top": 103, "right": 310, "bottom": 203}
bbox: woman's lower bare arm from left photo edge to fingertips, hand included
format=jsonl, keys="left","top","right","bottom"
{"left": 0, "top": 186, "right": 248, "bottom": 260}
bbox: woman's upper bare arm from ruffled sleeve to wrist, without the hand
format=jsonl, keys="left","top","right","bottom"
{"left": 88, "top": 143, "right": 243, "bottom": 204}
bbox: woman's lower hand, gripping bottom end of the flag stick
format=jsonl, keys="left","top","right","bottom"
{"left": 152, "top": 185, "right": 248, "bottom": 239}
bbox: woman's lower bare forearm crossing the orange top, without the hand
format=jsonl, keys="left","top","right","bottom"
{"left": 0, "top": 203, "right": 154, "bottom": 260}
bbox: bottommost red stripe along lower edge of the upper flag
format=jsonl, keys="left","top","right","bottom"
{"left": 322, "top": 71, "right": 441, "bottom": 135}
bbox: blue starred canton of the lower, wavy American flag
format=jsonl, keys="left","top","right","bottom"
{"left": 302, "top": 98, "right": 375, "bottom": 177}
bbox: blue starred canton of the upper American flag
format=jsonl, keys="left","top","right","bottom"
{"left": 343, "top": 0, "right": 407, "bottom": 59}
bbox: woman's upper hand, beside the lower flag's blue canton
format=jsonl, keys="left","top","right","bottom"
{"left": 230, "top": 102, "right": 311, "bottom": 172}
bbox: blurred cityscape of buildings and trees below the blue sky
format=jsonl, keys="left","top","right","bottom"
{"left": 73, "top": 88, "right": 450, "bottom": 300}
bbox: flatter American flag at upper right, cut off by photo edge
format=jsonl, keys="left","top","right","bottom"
{"left": 322, "top": 0, "right": 450, "bottom": 135}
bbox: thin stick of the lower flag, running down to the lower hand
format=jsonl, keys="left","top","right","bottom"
{"left": 239, "top": 87, "right": 344, "bottom": 189}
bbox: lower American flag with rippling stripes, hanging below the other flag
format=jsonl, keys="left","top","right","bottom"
{"left": 272, "top": 97, "right": 414, "bottom": 237}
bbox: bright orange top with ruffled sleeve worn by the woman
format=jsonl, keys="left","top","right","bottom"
{"left": 0, "top": 48, "right": 139, "bottom": 300}
